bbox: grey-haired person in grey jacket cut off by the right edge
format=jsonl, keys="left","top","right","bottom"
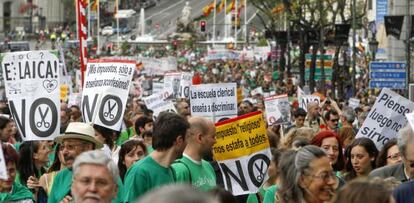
{"left": 369, "top": 124, "right": 414, "bottom": 182}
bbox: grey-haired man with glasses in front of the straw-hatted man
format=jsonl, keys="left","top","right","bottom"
{"left": 66, "top": 150, "right": 119, "bottom": 203}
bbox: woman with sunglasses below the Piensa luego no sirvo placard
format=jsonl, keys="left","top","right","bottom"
{"left": 376, "top": 138, "right": 402, "bottom": 168}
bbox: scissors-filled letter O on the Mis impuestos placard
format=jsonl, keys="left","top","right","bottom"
{"left": 99, "top": 94, "right": 122, "bottom": 126}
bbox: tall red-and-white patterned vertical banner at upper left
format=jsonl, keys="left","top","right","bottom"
{"left": 76, "top": 0, "right": 88, "bottom": 86}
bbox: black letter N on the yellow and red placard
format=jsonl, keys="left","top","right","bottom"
{"left": 220, "top": 160, "right": 249, "bottom": 192}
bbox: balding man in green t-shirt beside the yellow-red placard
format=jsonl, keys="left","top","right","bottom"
{"left": 172, "top": 117, "right": 216, "bottom": 191}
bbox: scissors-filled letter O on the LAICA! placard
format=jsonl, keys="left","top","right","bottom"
{"left": 29, "top": 98, "right": 58, "bottom": 137}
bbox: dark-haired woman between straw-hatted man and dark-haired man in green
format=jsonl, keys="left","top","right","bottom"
{"left": 118, "top": 139, "right": 148, "bottom": 181}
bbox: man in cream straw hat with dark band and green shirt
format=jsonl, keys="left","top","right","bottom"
{"left": 48, "top": 122, "right": 122, "bottom": 203}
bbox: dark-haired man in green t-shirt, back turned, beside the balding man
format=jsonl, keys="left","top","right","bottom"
{"left": 123, "top": 112, "right": 190, "bottom": 202}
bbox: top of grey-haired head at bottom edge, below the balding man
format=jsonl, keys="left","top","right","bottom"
{"left": 136, "top": 184, "right": 215, "bottom": 203}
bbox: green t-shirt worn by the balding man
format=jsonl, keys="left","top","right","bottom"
{"left": 172, "top": 156, "right": 216, "bottom": 191}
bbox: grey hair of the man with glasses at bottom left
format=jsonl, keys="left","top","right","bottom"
{"left": 73, "top": 150, "right": 119, "bottom": 184}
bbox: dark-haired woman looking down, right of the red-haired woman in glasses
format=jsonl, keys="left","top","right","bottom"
{"left": 345, "top": 137, "right": 378, "bottom": 181}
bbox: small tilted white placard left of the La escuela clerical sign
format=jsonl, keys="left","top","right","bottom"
{"left": 143, "top": 91, "right": 177, "bottom": 120}
